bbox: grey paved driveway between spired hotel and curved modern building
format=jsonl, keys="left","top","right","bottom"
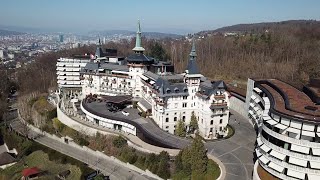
{"left": 206, "top": 109, "right": 256, "bottom": 180}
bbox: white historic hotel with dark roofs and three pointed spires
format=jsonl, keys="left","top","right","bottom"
{"left": 58, "top": 23, "right": 229, "bottom": 139}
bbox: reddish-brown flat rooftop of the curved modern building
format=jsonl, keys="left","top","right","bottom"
{"left": 256, "top": 79, "right": 320, "bottom": 123}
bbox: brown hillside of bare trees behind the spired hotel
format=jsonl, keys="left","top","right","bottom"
{"left": 13, "top": 21, "right": 320, "bottom": 95}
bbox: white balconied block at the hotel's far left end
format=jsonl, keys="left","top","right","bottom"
{"left": 57, "top": 58, "right": 90, "bottom": 88}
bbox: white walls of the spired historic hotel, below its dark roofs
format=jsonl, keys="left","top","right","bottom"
{"left": 81, "top": 63, "right": 229, "bottom": 139}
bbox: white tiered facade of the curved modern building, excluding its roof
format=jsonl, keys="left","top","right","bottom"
{"left": 246, "top": 80, "right": 320, "bottom": 180}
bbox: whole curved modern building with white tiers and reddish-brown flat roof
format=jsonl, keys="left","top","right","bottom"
{"left": 246, "top": 79, "right": 320, "bottom": 180}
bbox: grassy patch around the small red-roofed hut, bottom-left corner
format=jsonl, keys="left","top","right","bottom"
{"left": 0, "top": 150, "right": 81, "bottom": 180}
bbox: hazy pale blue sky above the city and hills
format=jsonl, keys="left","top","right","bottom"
{"left": 0, "top": 0, "right": 320, "bottom": 33}
